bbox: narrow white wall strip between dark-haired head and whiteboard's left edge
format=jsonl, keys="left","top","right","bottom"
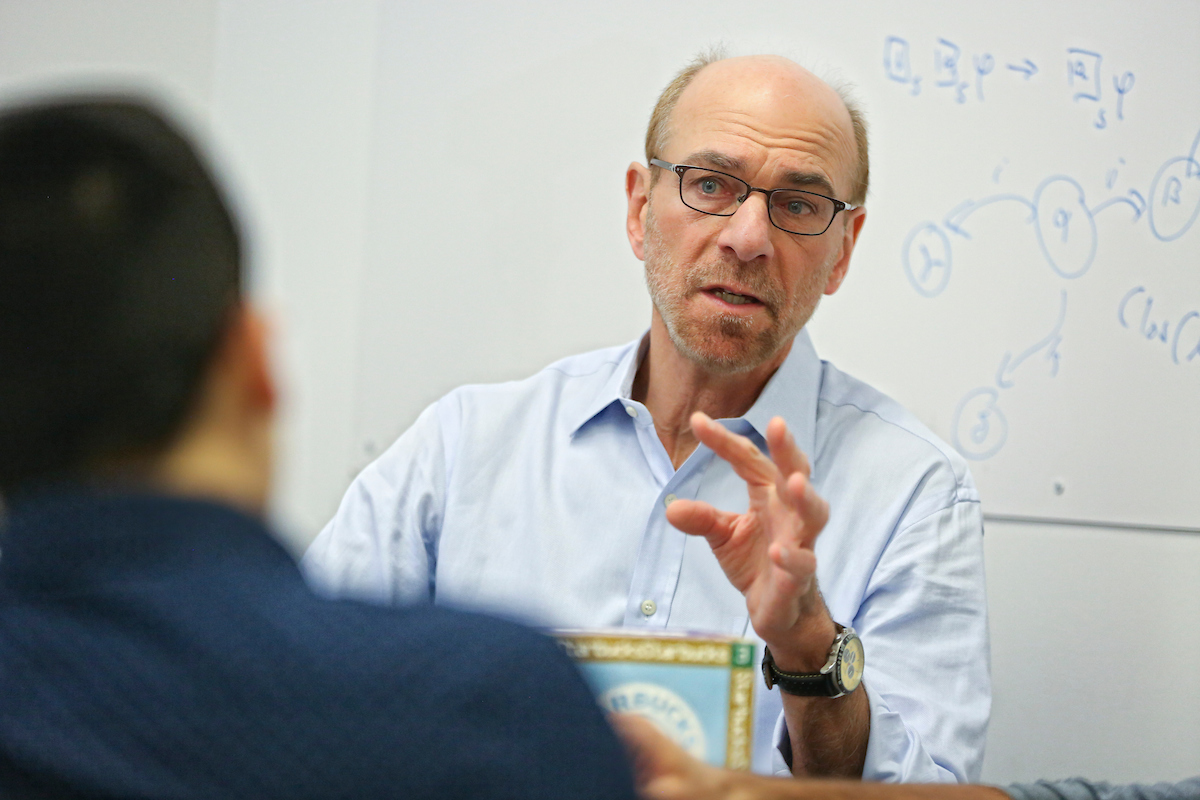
{"left": 212, "top": 0, "right": 379, "bottom": 549}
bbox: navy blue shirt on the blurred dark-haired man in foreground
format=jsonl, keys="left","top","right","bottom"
{"left": 0, "top": 491, "right": 632, "bottom": 799}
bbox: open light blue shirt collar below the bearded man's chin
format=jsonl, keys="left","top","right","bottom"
{"left": 571, "top": 329, "right": 821, "bottom": 461}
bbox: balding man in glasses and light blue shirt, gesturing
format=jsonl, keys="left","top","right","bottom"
{"left": 305, "top": 51, "right": 990, "bottom": 781}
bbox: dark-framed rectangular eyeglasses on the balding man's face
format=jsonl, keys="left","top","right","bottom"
{"left": 650, "top": 158, "right": 858, "bottom": 236}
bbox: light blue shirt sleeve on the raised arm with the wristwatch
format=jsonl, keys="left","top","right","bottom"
{"left": 773, "top": 501, "right": 991, "bottom": 783}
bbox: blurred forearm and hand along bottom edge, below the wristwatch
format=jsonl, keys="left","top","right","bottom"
{"left": 613, "top": 714, "right": 1200, "bottom": 800}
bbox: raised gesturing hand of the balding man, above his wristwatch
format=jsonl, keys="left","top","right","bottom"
{"left": 667, "top": 411, "right": 832, "bottom": 663}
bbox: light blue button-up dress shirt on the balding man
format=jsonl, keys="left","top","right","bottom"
{"left": 304, "top": 331, "right": 991, "bottom": 781}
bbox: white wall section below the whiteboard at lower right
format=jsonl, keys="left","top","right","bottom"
{"left": 984, "top": 522, "right": 1200, "bottom": 782}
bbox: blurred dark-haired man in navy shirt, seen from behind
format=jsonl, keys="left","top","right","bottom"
{"left": 0, "top": 100, "right": 632, "bottom": 799}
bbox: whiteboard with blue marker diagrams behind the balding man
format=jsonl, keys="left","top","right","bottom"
{"left": 354, "top": 6, "right": 1200, "bottom": 529}
